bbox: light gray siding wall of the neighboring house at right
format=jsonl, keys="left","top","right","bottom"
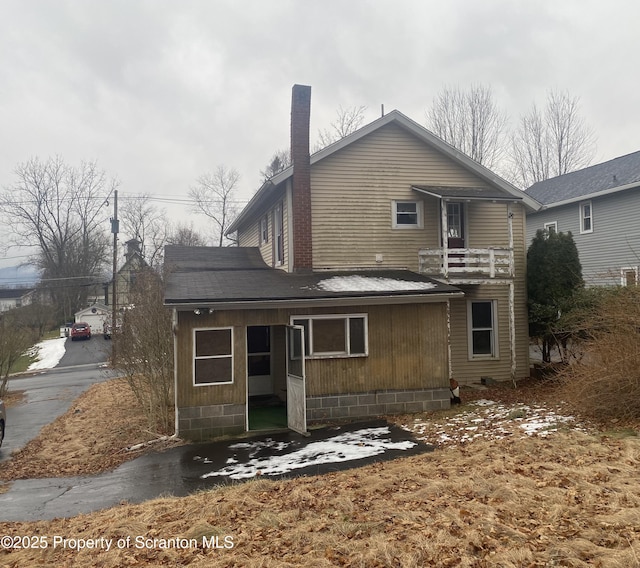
{"left": 527, "top": 188, "right": 640, "bottom": 286}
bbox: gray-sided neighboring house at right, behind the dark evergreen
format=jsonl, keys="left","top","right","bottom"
{"left": 527, "top": 152, "right": 640, "bottom": 286}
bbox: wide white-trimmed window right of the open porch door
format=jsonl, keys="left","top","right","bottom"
{"left": 291, "top": 314, "right": 369, "bottom": 359}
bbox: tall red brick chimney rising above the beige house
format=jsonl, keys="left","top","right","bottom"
{"left": 291, "top": 85, "right": 313, "bottom": 271}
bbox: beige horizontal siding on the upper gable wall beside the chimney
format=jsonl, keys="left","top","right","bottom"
{"left": 311, "top": 124, "right": 492, "bottom": 270}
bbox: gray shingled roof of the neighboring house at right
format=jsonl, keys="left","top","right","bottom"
{"left": 527, "top": 151, "right": 640, "bottom": 205}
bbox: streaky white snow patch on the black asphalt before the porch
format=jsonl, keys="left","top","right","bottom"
{"left": 201, "top": 426, "right": 417, "bottom": 479}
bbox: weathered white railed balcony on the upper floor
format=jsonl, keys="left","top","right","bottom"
{"left": 418, "top": 247, "right": 514, "bottom": 280}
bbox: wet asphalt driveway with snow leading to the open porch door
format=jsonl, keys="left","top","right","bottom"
{"left": 0, "top": 420, "right": 433, "bottom": 521}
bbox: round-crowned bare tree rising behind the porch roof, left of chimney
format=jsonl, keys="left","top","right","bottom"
{"left": 189, "top": 166, "right": 240, "bottom": 246}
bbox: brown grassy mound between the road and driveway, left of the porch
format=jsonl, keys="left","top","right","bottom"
{"left": 0, "top": 379, "right": 178, "bottom": 480}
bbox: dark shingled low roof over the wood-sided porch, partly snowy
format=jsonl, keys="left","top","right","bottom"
{"left": 165, "top": 246, "right": 462, "bottom": 306}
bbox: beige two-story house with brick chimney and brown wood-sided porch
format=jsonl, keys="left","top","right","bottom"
{"left": 165, "top": 85, "right": 537, "bottom": 439}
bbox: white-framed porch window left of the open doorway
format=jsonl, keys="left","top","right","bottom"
{"left": 193, "top": 327, "right": 233, "bottom": 386}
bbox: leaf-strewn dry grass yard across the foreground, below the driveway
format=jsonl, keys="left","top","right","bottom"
{"left": 0, "top": 383, "right": 640, "bottom": 568}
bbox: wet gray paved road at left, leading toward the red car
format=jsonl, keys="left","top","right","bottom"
{"left": 0, "top": 337, "right": 116, "bottom": 462}
